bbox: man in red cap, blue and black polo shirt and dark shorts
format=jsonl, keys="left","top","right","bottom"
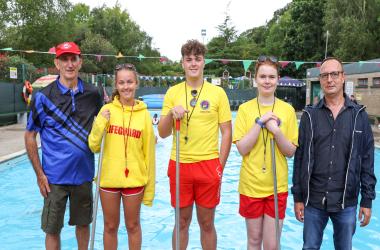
{"left": 25, "top": 42, "right": 102, "bottom": 249}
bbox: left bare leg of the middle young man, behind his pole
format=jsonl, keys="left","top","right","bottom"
{"left": 172, "top": 205, "right": 193, "bottom": 250}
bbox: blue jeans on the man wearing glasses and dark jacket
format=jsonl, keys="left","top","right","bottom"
{"left": 302, "top": 205, "right": 356, "bottom": 250}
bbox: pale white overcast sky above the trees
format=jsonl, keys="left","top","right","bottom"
{"left": 70, "top": 0, "right": 291, "bottom": 60}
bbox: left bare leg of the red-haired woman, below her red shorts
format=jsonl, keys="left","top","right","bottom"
{"left": 245, "top": 216, "right": 264, "bottom": 250}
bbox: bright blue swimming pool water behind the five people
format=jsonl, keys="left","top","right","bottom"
{"left": 0, "top": 112, "right": 380, "bottom": 250}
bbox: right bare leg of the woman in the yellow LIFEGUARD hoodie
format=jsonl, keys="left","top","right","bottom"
{"left": 122, "top": 192, "right": 144, "bottom": 250}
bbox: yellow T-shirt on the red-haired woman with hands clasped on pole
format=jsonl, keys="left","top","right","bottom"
{"left": 233, "top": 98, "right": 298, "bottom": 198}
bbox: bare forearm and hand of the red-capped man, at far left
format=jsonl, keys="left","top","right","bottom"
{"left": 24, "top": 131, "right": 50, "bottom": 197}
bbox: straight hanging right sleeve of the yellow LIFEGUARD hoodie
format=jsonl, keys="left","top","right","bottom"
{"left": 143, "top": 111, "right": 156, "bottom": 206}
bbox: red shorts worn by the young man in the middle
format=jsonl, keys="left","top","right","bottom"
{"left": 168, "top": 158, "right": 223, "bottom": 208}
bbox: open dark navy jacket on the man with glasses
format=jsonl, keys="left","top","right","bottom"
{"left": 291, "top": 100, "right": 376, "bottom": 209}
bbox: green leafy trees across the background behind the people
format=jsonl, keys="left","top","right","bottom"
{"left": 0, "top": 0, "right": 380, "bottom": 84}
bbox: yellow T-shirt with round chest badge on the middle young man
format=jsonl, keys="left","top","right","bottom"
{"left": 161, "top": 81, "right": 231, "bottom": 163}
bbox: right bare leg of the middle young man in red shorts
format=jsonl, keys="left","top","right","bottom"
{"left": 197, "top": 205, "right": 217, "bottom": 250}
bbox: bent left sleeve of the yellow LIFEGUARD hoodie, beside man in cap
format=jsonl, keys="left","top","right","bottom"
{"left": 88, "top": 106, "right": 108, "bottom": 153}
